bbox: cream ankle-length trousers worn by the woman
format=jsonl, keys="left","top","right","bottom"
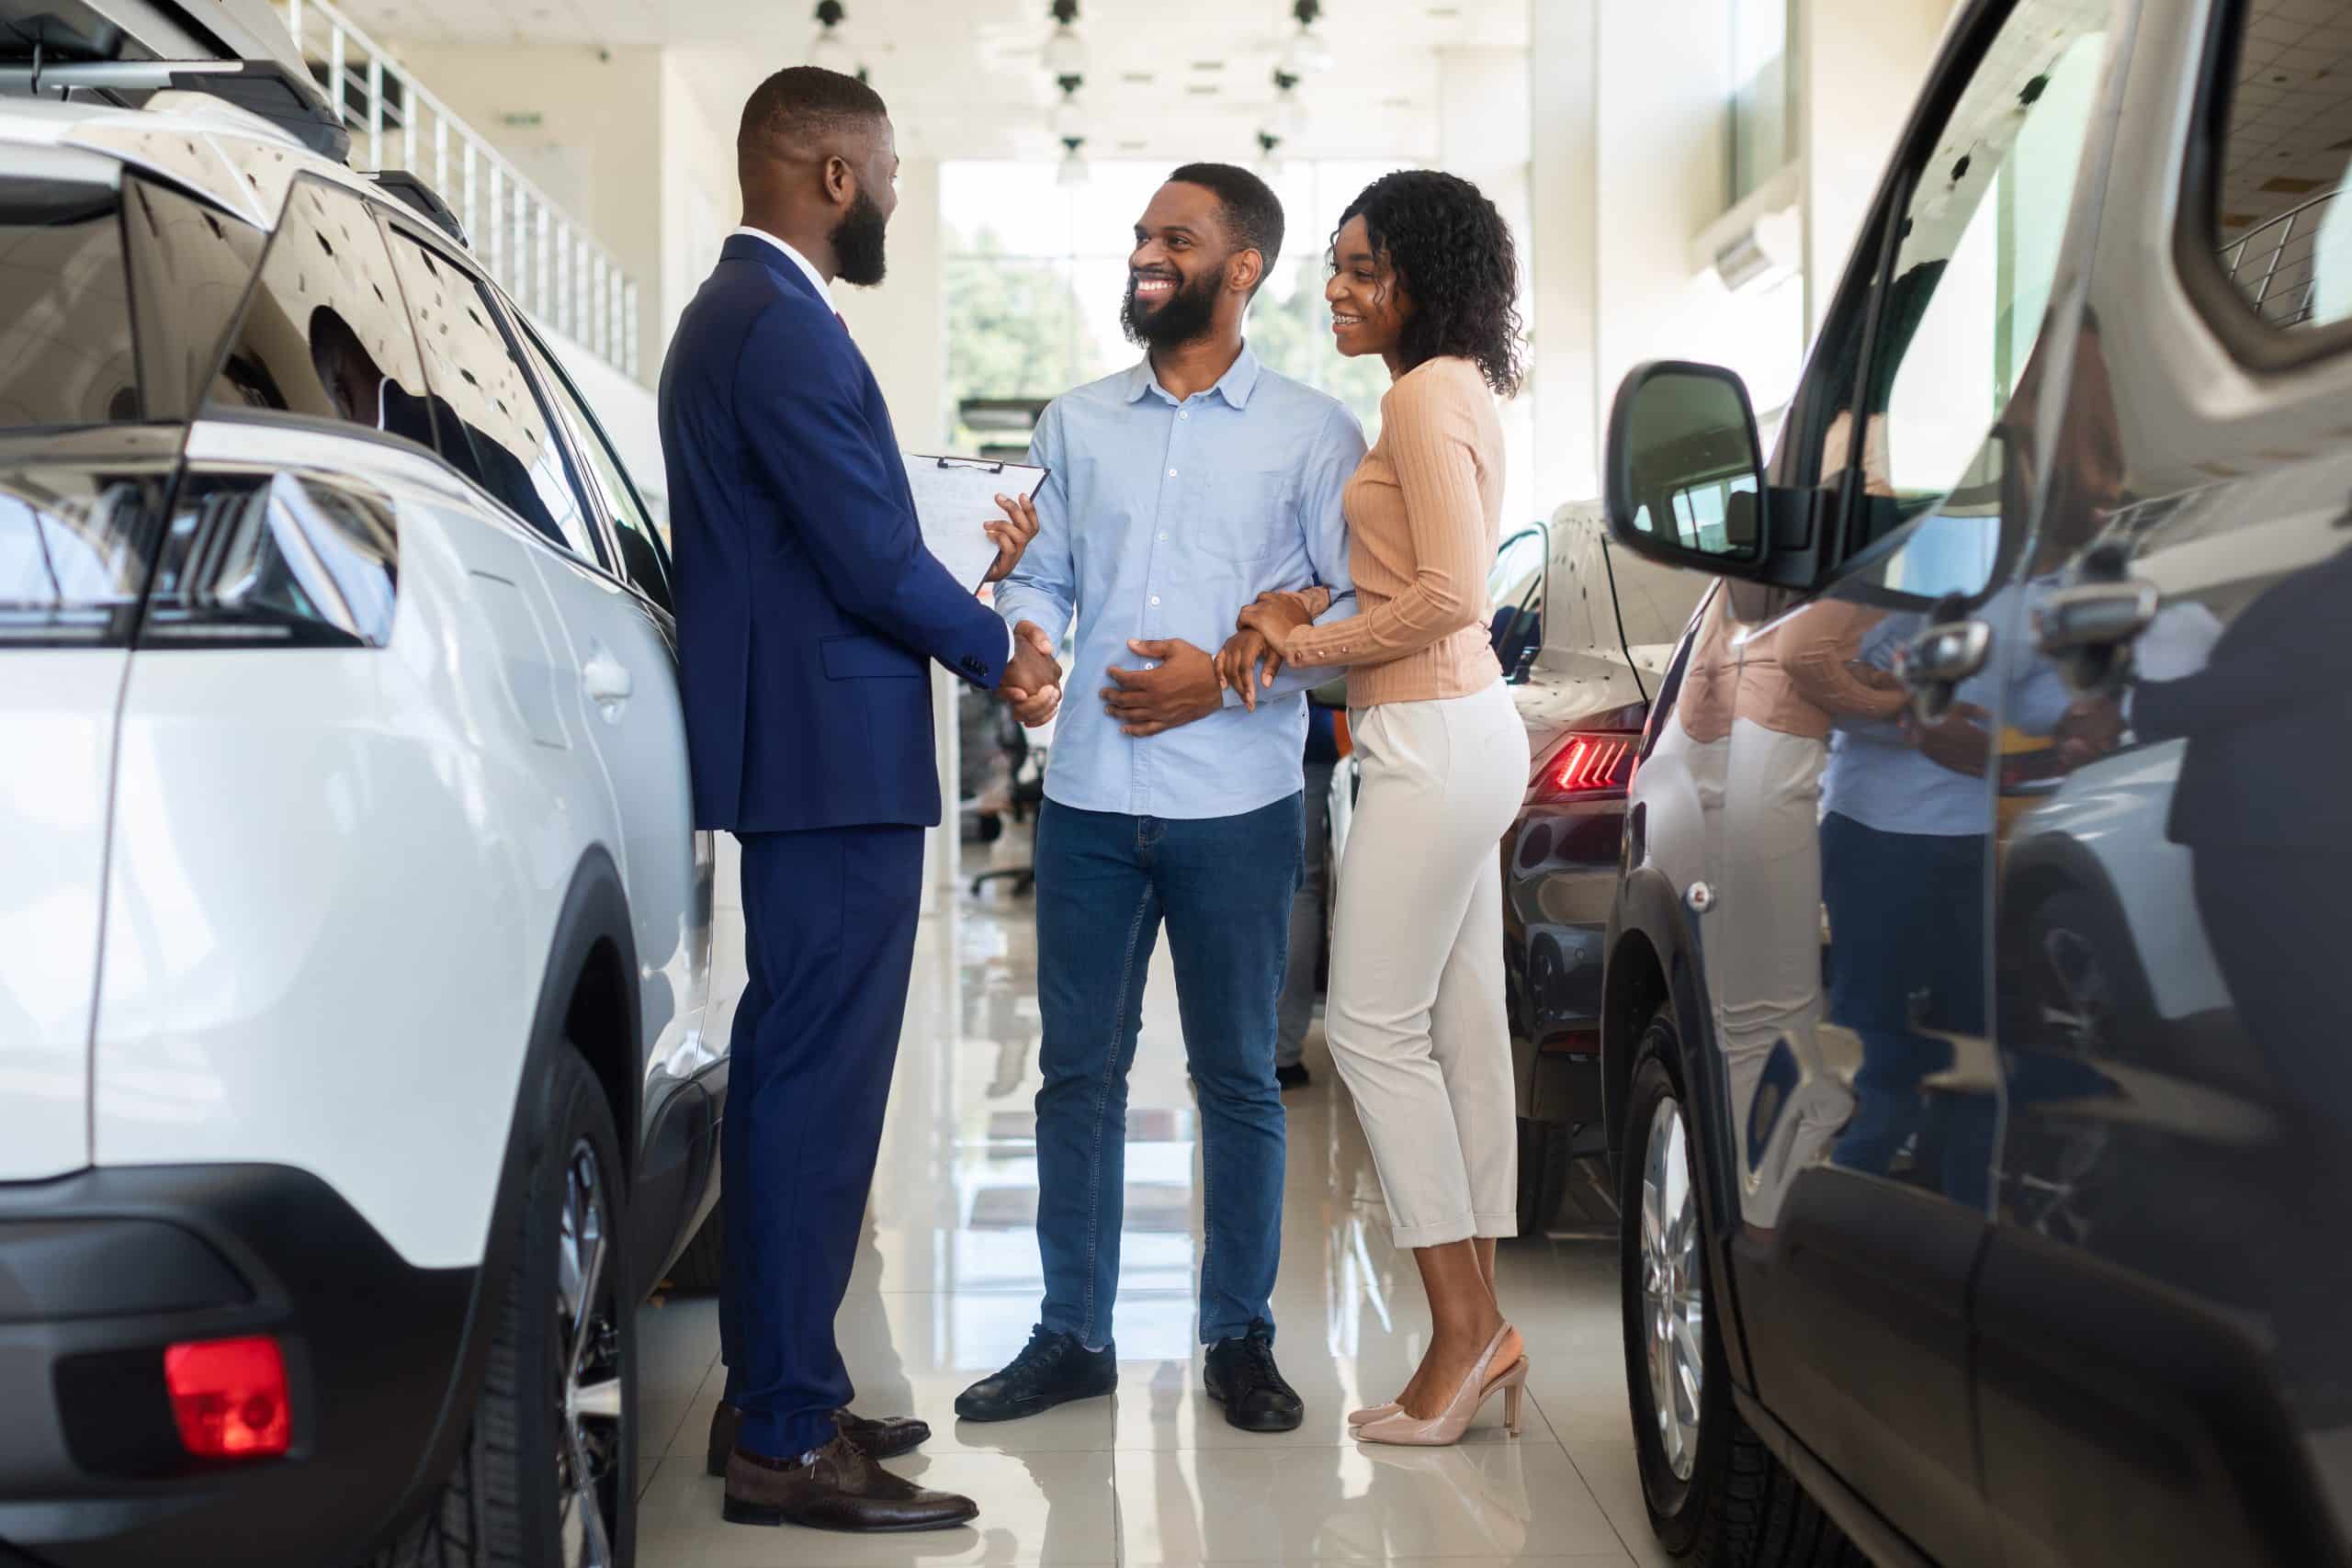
{"left": 1324, "top": 682, "right": 1526, "bottom": 1246}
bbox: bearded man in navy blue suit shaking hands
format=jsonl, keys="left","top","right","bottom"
{"left": 661, "top": 68, "right": 1061, "bottom": 1530}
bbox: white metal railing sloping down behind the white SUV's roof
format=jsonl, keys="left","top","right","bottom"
{"left": 273, "top": 0, "right": 638, "bottom": 378}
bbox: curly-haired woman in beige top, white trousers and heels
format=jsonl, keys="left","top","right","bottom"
{"left": 1221, "top": 169, "right": 1526, "bottom": 1443}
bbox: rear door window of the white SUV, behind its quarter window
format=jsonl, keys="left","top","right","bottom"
{"left": 379, "top": 231, "right": 605, "bottom": 562}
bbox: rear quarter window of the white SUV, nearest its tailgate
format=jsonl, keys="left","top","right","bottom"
{"left": 205, "top": 179, "right": 433, "bottom": 446}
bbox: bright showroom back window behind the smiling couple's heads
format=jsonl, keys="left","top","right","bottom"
{"left": 941, "top": 163, "right": 1397, "bottom": 449}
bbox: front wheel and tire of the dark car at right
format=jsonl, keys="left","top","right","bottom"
{"left": 1618, "top": 1006, "right": 1860, "bottom": 1568}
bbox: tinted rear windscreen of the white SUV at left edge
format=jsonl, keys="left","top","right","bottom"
{"left": 0, "top": 174, "right": 148, "bottom": 430}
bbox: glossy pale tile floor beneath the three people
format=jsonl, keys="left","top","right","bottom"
{"left": 638, "top": 841, "right": 1663, "bottom": 1568}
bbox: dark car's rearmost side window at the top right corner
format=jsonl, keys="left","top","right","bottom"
{"left": 2211, "top": 5, "right": 2352, "bottom": 332}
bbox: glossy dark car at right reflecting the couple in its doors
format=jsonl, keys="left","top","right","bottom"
{"left": 1601, "top": 0, "right": 2352, "bottom": 1568}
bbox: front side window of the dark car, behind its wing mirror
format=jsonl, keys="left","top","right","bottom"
{"left": 1820, "top": 0, "right": 2109, "bottom": 564}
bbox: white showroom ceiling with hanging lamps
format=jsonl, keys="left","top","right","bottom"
{"left": 339, "top": 0, "right": 1533, "bottom": 160}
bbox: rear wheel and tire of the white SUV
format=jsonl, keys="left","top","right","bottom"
{"left": 374, "top": 1043, "right": 638, "bottom": 1568}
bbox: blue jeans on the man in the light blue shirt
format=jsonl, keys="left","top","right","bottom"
{"left": 1035, "top": 795, "right": 1303, "bottom": 1349}
